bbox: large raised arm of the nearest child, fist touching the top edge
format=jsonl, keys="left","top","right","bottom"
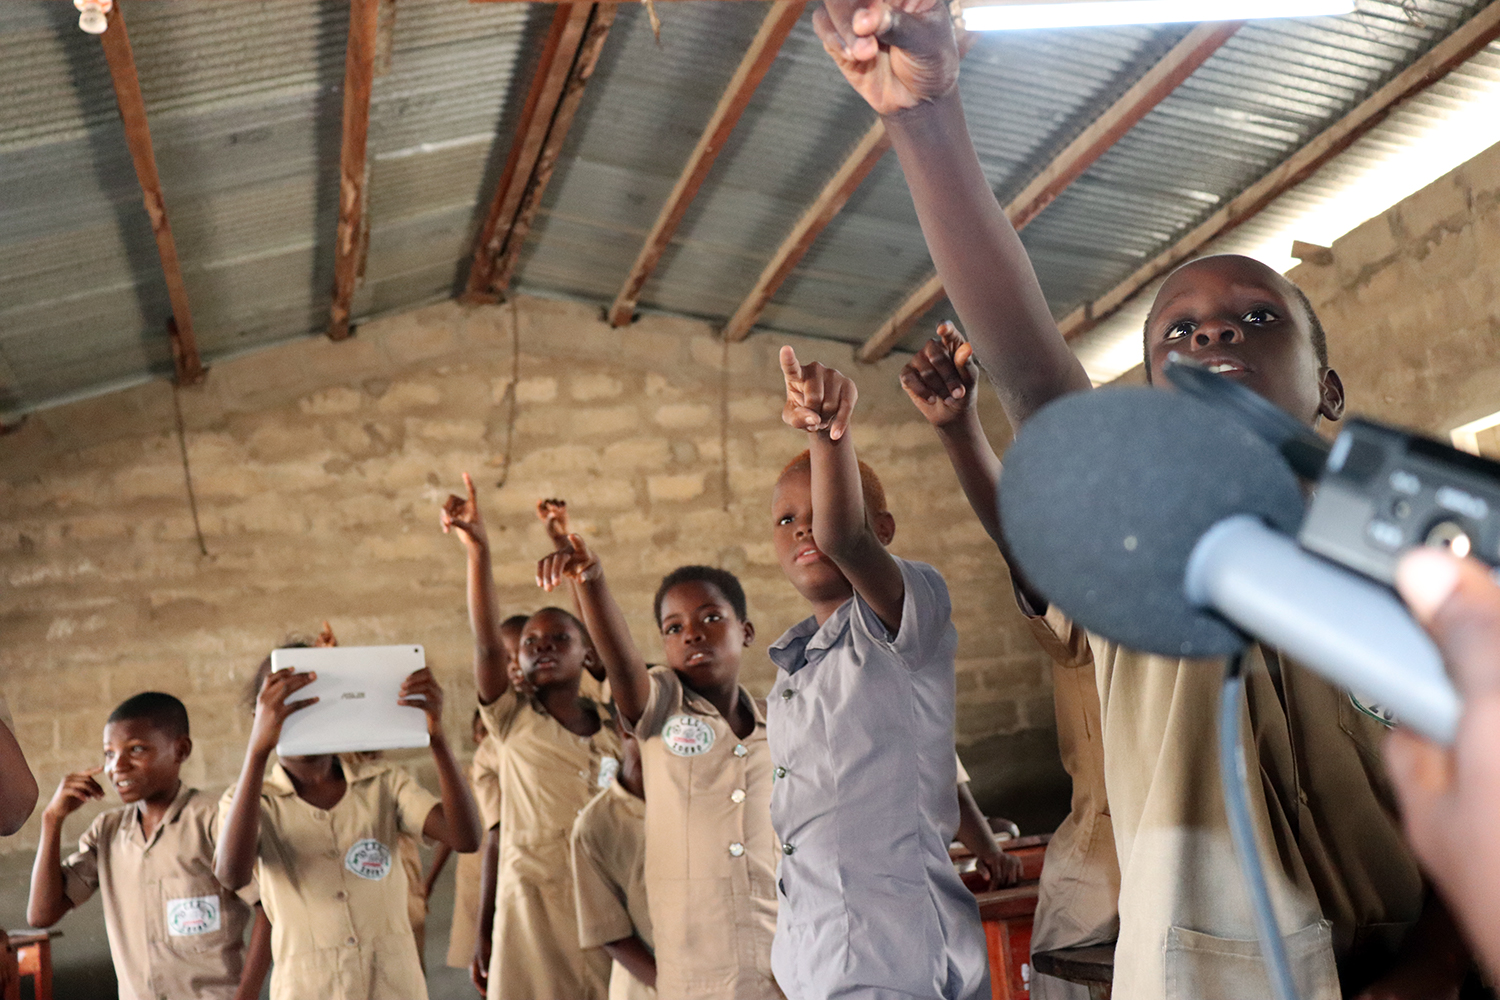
{"left": 813, "top": 0, "right": 1089, "bottom": 427}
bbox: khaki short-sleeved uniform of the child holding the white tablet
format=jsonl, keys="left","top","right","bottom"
{"left": 221, "top": 757, "right": 438, "bottom": 1000}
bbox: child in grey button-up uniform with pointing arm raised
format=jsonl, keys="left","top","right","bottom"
{"left": 767, "top": 348, "right": 990, "bottom": 1000}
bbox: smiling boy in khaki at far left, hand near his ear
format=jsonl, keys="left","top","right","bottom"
{"left": 27, "top": 691, "right": 266, "bottom": 1000}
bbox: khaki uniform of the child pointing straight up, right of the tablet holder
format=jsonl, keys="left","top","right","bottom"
{"left": 480, "top": 690, "right": 620, "bottom": 1000}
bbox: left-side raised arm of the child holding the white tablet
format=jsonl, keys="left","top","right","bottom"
{"left": 213, "top": 669, "right": 318, "bottom": 889}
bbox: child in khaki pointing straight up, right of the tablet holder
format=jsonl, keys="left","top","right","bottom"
{"left": 443, "top": 475, "right": 618, "bottom": 1000}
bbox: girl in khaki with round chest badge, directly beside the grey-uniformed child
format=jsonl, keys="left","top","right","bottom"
{"left": 539, "top": 535, "right": 782, "bottom": 1000}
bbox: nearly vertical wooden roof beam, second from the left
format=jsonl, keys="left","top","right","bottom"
{"left": 329, "top": 0, "right": 380, "bottom": 340}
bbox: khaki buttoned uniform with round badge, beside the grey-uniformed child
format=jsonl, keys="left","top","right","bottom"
{"left": 636, "top": 667, "right": 782, "bottom": 1000}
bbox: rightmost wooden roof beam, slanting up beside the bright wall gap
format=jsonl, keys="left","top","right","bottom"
{"left": 1058, "top": 0, "right": 1500, "bottom": 340}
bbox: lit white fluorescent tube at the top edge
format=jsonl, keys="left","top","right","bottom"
{"left": 963, "top": 0, "right": 1355, "bottom": 31}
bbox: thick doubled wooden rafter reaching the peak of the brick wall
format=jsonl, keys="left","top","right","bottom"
{"left": 464, "top": 3, "right": 615, "bottom": 301}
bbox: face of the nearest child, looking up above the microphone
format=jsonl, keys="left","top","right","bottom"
{"left": 1146, "top": 255, "right": 1343, "bottom": 424}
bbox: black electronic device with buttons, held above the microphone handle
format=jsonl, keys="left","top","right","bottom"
{"left": 1298, "top": 418, "right": 1500, "bottom": 586}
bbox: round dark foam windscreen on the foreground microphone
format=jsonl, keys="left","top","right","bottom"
{"left": 999, "top": 388, "right": 1304, "bottom": 657}
